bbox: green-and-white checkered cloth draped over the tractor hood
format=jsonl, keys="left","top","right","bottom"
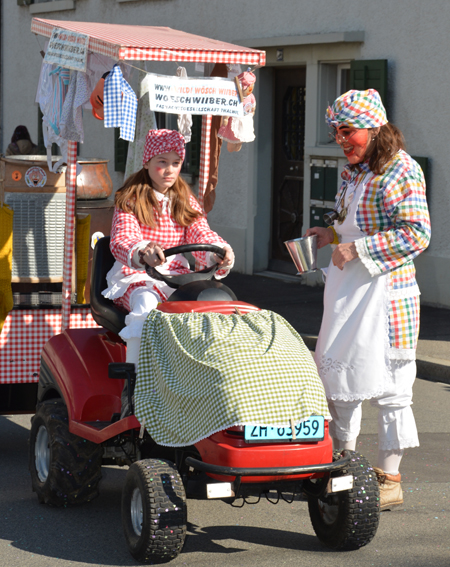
{"left": 134, "top": 310, "right": 330, "bottom": 447}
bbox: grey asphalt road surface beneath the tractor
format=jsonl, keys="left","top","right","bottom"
{"left": 0, "top": 380, "right": 450, "bottom": 567}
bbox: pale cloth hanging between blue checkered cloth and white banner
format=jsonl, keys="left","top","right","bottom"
{"left": 125, "top": 71, "right": 158, "bottom": 179}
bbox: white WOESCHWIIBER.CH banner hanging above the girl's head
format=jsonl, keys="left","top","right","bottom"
{"left": 149, "top": 74, "right": 244, "bottom": 117}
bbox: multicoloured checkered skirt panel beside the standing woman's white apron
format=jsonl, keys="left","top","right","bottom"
{"left": 389, "top": 296, "right": 420, "bottom": 349}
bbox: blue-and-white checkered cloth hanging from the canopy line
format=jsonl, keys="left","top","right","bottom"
{"left": 103, "top": 64, "right": 137, "bottom": 142}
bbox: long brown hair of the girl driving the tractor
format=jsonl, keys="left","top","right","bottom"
{"left": 114, "top": 168, "right": 202, "bottom": 228}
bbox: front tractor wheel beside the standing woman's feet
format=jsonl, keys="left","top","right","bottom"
{"left": 308, "top": 453, "right": 380, "bottom": 550}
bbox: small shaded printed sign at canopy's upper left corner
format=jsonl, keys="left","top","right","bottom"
{"left": 44, "top": 28, "right": 89, "bottom": 72}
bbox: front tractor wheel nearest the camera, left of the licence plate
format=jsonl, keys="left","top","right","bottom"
{"left": 122, "top": 459, "right": 187, "bottom": 563}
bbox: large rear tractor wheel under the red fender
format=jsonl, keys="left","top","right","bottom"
{"left": 29, "top": 399, "right": 102, "bottom": 506}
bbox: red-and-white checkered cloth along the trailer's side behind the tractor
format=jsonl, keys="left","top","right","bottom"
{"left": 0, "top": 308, "right": 98, "bottom": 384}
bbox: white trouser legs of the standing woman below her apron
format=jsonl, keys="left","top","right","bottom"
{"left": 328, "top": 360, "right": 419, "bottom": 451}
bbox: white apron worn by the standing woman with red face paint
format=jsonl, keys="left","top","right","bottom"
{"left": 315, "top": 178, "right": 392, "bottom": 401}
